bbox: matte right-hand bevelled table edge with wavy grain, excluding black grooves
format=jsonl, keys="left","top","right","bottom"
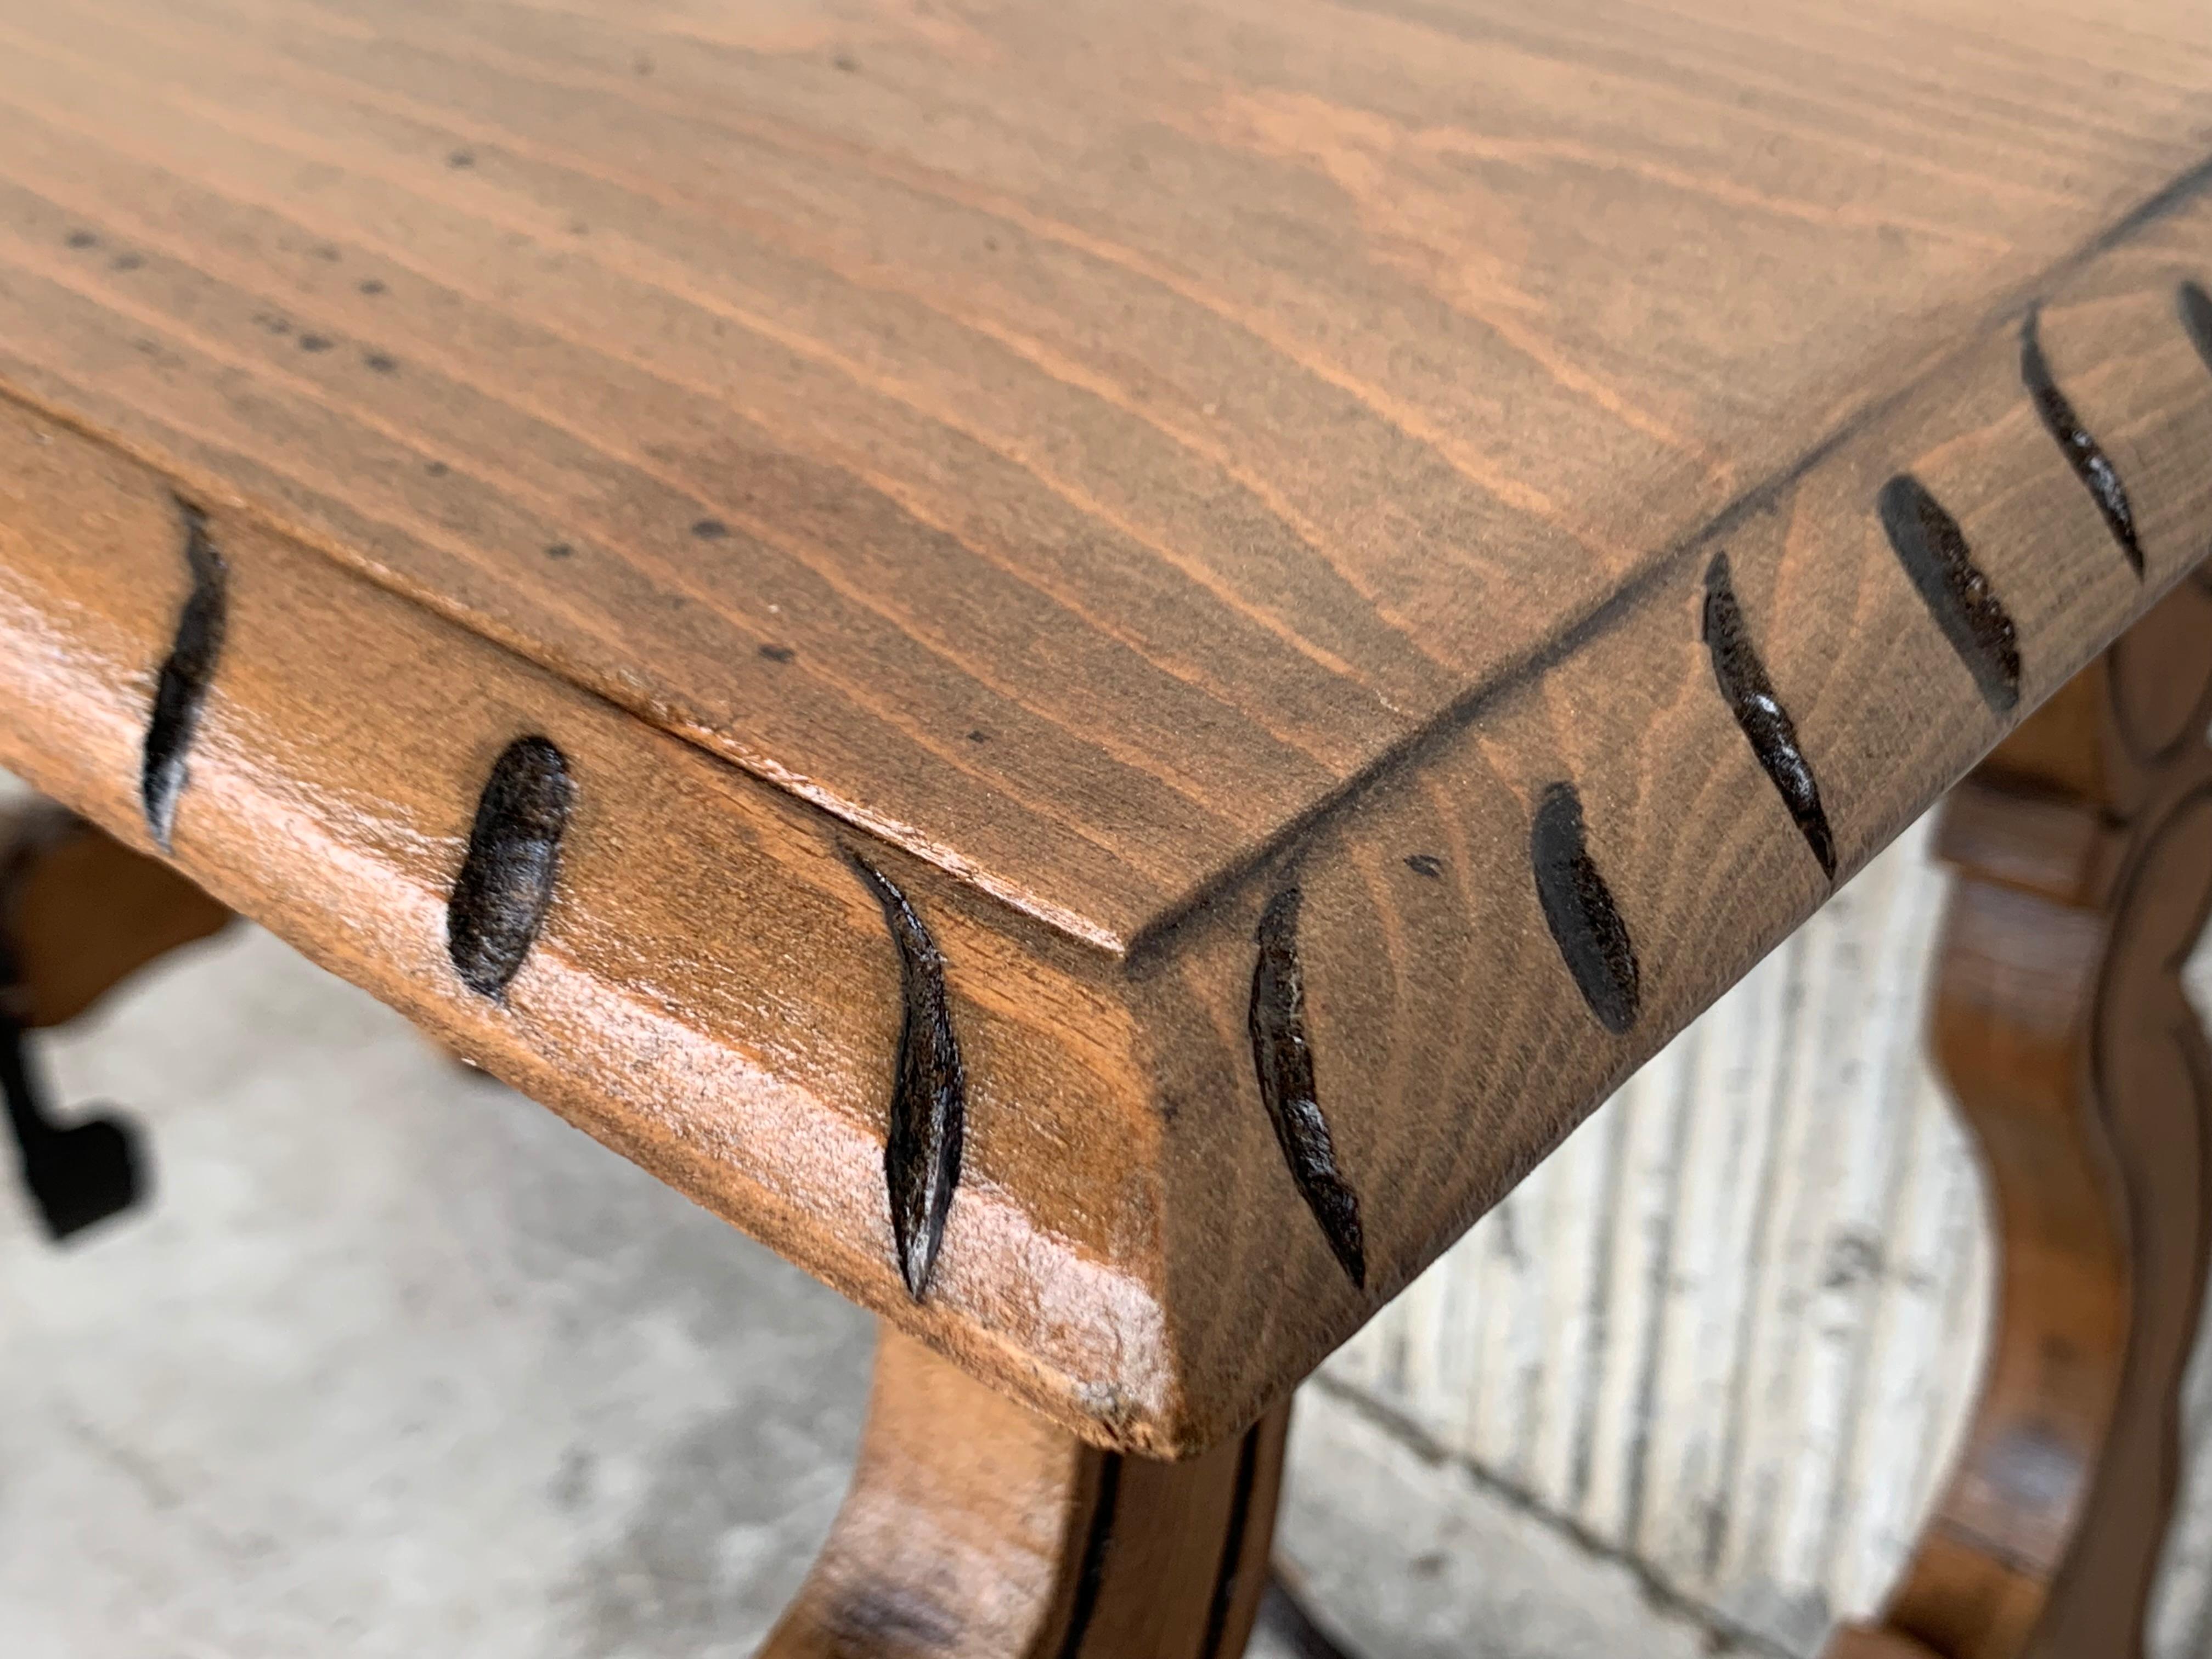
{"left": 1137, "top": 208, "right": 2212, "bottom": 1451}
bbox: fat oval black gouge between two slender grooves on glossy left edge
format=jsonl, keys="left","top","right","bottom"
{"left": 444, "top": 737, "right": 575, "bottom": 997}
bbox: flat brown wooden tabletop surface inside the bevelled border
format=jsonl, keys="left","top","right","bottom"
{"left": 0, "top": 0, "right": 2212, "bottom": 949}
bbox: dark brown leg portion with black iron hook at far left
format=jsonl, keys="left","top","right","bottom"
{"left": 0, "top": 803, "right": 230, "bottom": 1239}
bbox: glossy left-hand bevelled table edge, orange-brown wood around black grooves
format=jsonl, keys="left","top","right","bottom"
{"left": 0, "top": 396, "right": 1212, "bottom": 1444}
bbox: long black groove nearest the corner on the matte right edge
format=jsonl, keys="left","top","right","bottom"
{"left": 1250, "top": 887, "right": 1367, "bottom": 1290}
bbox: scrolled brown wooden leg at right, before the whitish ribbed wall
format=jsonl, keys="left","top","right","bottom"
{"left": 1829, "top": 579, "right": 2212, "bottom": 1659}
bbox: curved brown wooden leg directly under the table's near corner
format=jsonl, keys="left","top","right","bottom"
{"left": 761, "top": 1327, "right": 1290, "bottom": 1659}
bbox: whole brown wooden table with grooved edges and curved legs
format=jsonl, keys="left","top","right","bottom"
{"left": 0, "top": 0, "right": 2212, "bottom": 1659}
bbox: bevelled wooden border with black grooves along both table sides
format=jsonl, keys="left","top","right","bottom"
{"left": 0, "top": 208, "right": 2212, "bottom": 1455}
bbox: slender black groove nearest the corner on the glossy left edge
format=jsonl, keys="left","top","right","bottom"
{"left": 845, "top": 851, "right": 967, "bottom": 1301}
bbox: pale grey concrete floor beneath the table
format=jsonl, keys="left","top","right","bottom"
{"left": 0, "top": 927, "right": 1710, "bottom": 1659}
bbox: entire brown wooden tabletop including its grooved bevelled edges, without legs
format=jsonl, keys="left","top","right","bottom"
{"left": 0, "top": 0, "right": 2212, "bottom": 1449}
